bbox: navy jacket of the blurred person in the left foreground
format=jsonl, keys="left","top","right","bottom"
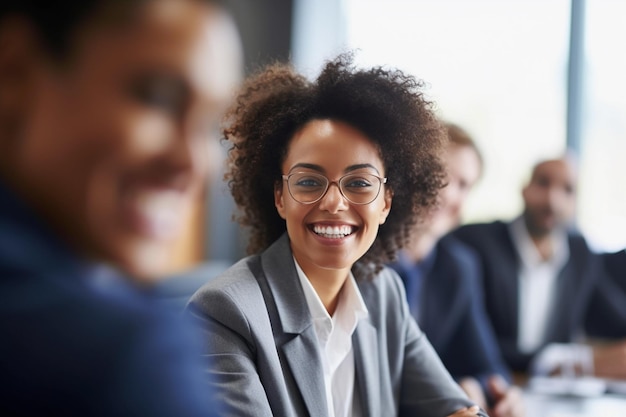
{"left": 0, "top": 180, "right": 219, "bottom": 417}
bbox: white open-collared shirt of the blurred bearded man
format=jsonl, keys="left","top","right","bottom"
{"left": 510, "top": 216, "right": 569, "bottom": 353}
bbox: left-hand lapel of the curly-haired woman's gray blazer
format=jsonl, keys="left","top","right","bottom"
{"left": 261, "top": 234, "right": 328, "bottom": 417}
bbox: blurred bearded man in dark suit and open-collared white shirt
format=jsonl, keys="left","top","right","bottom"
{"left": 454, "top": 154, "right": 626, "bottom": 376}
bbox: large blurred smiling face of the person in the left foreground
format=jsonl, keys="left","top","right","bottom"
{"left": 13, "top": 0, "right": 241, "bottom": 277}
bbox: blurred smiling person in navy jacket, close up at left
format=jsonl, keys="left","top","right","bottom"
{"left": 0, "top": 0, "right": 241, "bottom": 416}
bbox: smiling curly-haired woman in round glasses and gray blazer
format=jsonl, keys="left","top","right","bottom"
{"left": 186, "top": 55, "right": 484, "bottom": 417}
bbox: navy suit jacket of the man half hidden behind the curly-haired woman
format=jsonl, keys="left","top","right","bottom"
{"left": 390, "top": 236, "right": 510, "bottom": 385}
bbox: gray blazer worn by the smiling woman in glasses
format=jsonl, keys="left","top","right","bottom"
{"left": 186, "top": 235, "right": 478, "bottom": 417}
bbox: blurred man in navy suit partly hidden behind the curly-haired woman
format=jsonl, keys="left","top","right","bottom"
{"left": 390, "top": 123, "right": 523, "bottom": 417}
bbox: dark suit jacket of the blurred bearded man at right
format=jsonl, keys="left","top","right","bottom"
{"left": 453, "top": 221, "right": 602, "bottom": 371}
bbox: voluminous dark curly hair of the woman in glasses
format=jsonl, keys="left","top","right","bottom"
{"left": 224, "top": 54, "right": 446, "bottom": 279}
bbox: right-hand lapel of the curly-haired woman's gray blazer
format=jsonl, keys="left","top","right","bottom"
{"left": 352, "top": 320, "right": 381, "bottom": 417}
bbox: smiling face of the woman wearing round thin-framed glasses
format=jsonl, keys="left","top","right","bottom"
{"left": 274, "top": 120, "right": 391, "bottom": 275}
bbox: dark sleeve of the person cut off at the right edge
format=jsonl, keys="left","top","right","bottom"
{"left": 585, "top": 250, "right": 626, "bottom": 339}
